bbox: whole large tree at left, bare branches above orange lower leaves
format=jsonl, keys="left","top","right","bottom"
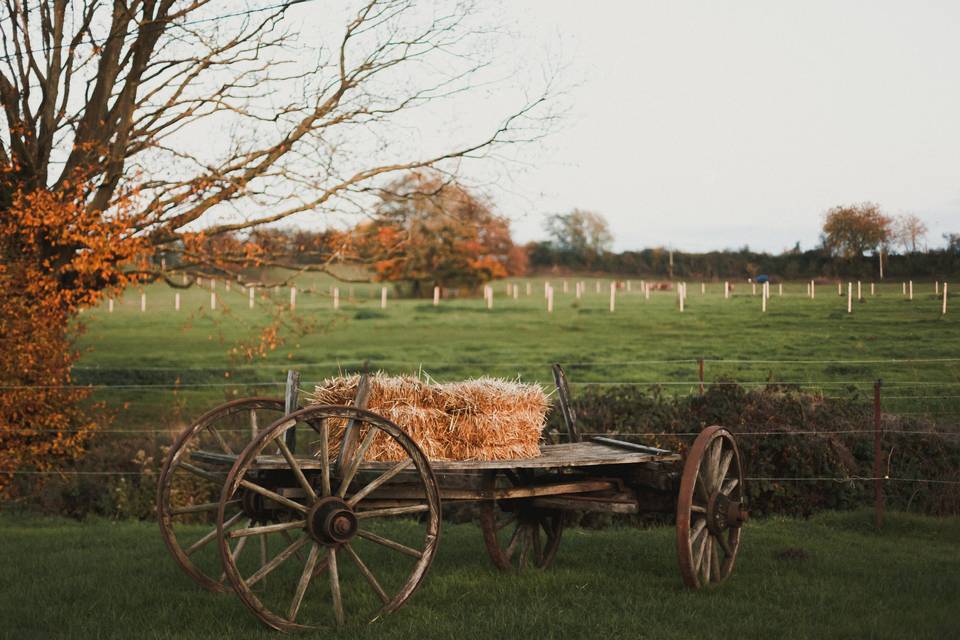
{"left": 0, "top": 0, "right": 553, "bottom": 490}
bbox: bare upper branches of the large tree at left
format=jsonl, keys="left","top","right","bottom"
{"left": 0, "top": 0, "right": 551, "bottom": 284}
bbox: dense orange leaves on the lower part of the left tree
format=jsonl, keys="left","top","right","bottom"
{"left": 0, "top": 185, "right": 147, "bottom": 492}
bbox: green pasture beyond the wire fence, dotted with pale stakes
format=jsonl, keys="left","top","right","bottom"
{"left": 76, "top": 276, "right": 960, "bottom": 428}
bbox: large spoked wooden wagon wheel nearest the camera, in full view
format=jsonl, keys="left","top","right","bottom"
{"left": 217, "top": 405, "right": 441, "bottom": 631}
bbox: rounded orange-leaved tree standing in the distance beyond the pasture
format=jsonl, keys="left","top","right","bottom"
{"left": 360, "top": 171, "right": 518, "bottom": 297}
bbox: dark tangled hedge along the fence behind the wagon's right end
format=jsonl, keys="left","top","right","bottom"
{"left": 548, "top": 383, "right": 960, "bottom": 516}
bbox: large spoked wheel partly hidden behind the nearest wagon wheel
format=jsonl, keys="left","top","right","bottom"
{"left": 157, "top": 398, "right": 283, "bottom": 591}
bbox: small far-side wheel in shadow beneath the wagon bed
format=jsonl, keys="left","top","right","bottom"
{"left": 480, "top": 471, "right": 564, "bottom": 571}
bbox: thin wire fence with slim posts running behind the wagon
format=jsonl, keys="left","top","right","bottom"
{"left": 0, "top": 357, "right": 960, "bottom": 524}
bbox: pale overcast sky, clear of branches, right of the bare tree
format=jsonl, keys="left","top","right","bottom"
{"left": 488, "top": 0, "right": 960, "bottom": 252}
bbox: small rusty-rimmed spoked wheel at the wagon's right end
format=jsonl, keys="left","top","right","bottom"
{"left": 677, "top": 426, "right": 747, "bottom": 589}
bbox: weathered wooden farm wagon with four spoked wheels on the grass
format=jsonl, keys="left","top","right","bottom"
{"left": 157, "top": 365, "right": 747, "bottom": 631}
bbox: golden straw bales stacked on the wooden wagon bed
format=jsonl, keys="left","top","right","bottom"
{"left": 308, "top": 373, "right": 549, "bottom": 460}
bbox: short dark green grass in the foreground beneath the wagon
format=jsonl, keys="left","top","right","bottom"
{"left": 0, "top": 511, "right": 960, "bottom": 640}
